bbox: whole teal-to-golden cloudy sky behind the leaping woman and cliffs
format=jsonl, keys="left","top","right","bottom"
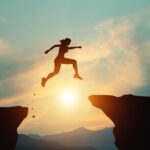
{"left": 0, "top": 0, "right": 150, "bottom": 135}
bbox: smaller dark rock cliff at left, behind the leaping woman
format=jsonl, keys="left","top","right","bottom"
{"left": 0, "top": 106, "right": 28, "bottom": 150}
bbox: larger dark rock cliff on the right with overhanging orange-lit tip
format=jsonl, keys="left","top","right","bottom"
{"left": 89, "top": 95, "right": 150, "bottom": 150}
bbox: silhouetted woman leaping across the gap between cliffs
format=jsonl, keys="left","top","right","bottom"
{"left": 41, "top": 38, "right": 83, "bottom": 87}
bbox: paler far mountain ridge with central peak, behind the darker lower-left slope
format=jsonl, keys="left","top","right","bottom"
{"left": 28, "top": 127, "right": 117, "bottom": 150}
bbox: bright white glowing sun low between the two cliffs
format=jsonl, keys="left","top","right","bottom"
{"left": 60, "top": 90, "right": 77, "bottom": 107}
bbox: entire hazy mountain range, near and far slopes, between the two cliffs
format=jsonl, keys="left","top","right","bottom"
{"left": 16, "top": 128, "right": 117, "bottom": 150}
